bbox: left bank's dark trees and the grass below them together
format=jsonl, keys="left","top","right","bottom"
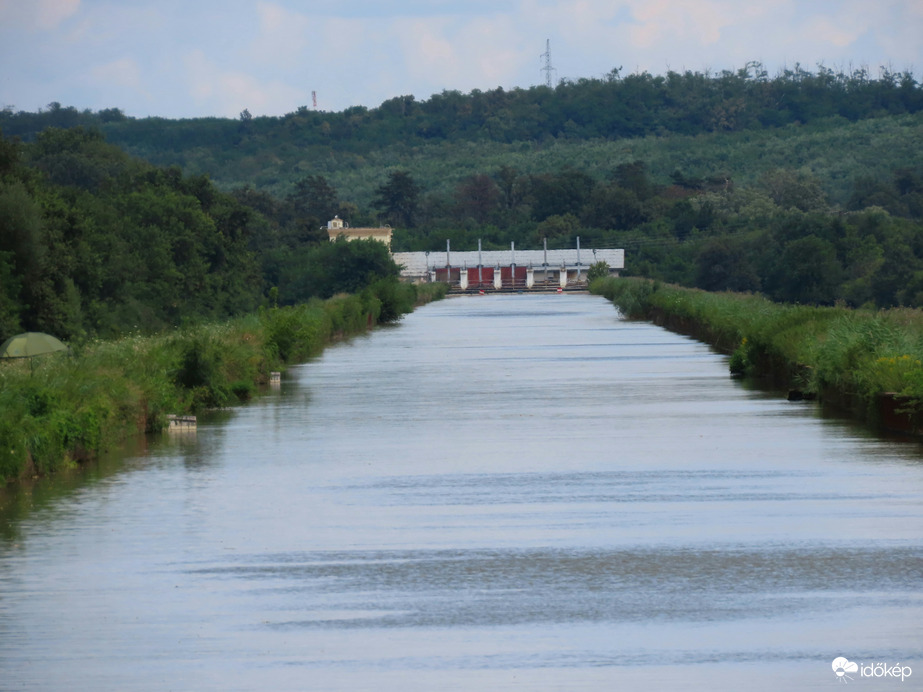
{"left": 0, "top": 111, "right": 444, "bottom": 481}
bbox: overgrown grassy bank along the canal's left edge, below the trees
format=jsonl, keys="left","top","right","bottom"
{"left": 0, "top": 280, "right": 445, "bottom": 482}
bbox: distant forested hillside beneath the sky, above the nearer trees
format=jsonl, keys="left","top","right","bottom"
{"left": 0, "top": 63, "right": 923, "bottom": 203}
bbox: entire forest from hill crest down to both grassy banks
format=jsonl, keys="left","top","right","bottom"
{"left": 0, "top": 64, "right": 923, "bottom": 336}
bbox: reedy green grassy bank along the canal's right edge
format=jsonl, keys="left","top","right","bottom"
{"left": 590, "top": 278, "right": 923, "bottom": 433}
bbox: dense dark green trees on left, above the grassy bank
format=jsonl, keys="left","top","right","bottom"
{"left": 0, "top": 128, "right": 399, "bottom": 339}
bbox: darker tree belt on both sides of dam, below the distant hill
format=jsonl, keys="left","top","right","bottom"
{"left": 7, "top": 123, "right": 923, "bottom": 338}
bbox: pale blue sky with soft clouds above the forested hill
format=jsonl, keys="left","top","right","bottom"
{"left": 0, "top": 0, "right": 923, "bottom": 118}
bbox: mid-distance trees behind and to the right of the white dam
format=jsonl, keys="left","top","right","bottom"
{"left": 253, "top": 161, "right": 923, "bottom": 307}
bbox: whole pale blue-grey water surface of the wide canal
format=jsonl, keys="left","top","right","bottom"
{"left": 0, "top": 295, "right": 923, "bottom": 690}
